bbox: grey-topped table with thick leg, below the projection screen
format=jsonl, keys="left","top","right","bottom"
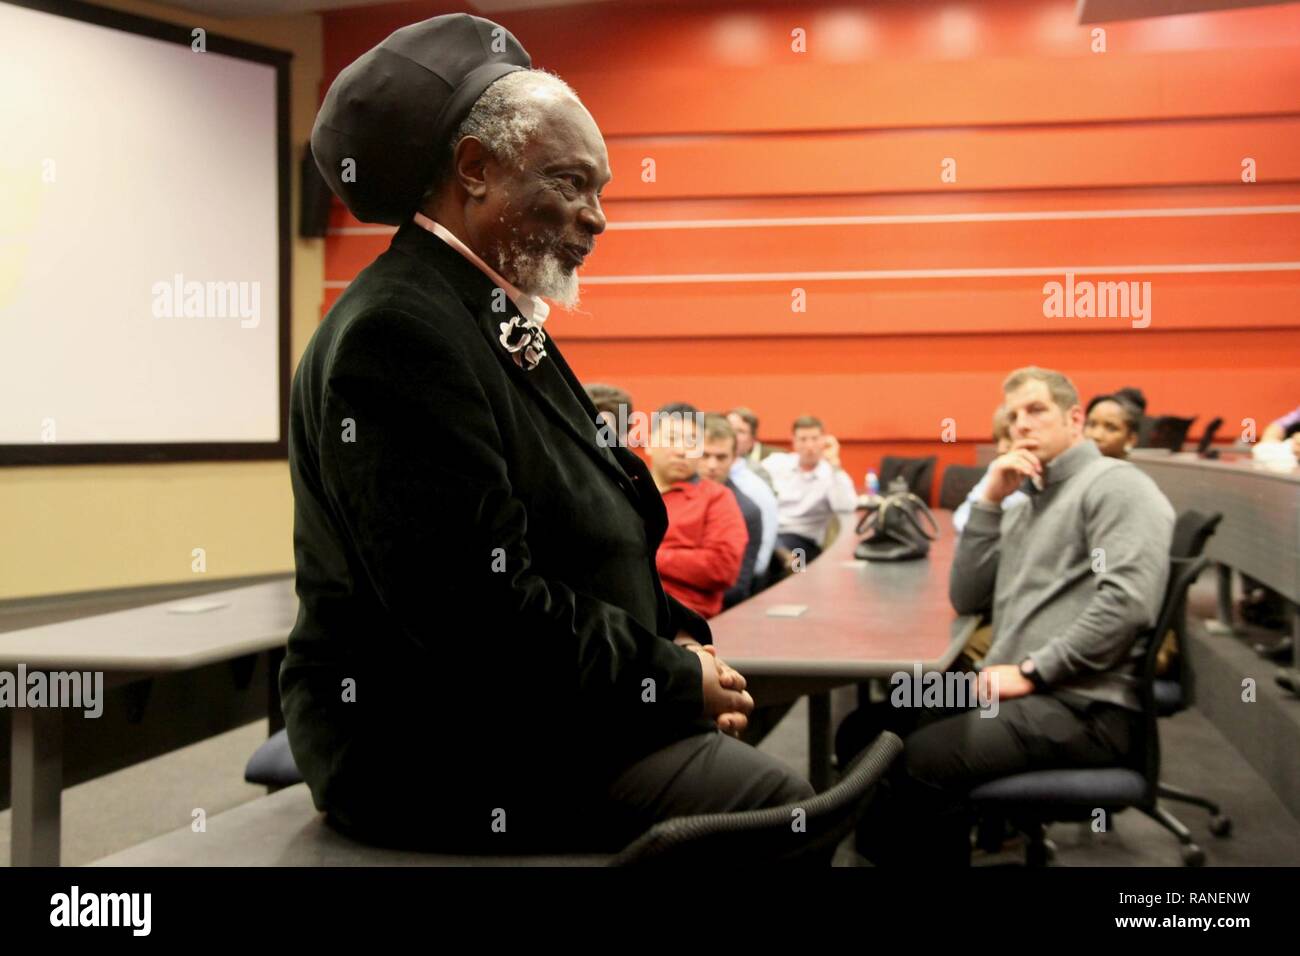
{"left": 0, "top": 578, "right": 298, "bottom": 866}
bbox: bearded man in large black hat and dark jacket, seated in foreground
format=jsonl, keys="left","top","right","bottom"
{"left": 281, "top": 14, "right": 811, "bottom": 851}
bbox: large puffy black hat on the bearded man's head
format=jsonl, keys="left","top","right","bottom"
{"left": 312, "top": 13, "right": 533, "bottom": 225}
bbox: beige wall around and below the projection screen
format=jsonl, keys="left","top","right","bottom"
{"left": 0, "top": 0, "right": 325, "bottom": 600}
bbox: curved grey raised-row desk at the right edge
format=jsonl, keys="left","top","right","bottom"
{"left": 1130, "top": 449, "right": 1300, "bottom": 671}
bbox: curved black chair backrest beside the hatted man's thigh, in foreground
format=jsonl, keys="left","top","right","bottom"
{"left": 610, "top": 731, "right": 902, "bottom": 866}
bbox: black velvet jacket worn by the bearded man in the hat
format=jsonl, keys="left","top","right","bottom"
{"left": 281, "top": 222, "right": 712, "bottom": 848}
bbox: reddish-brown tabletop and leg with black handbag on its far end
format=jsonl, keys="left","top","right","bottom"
{"left": 709, "top": 511, "right": 979, "bottom": 792}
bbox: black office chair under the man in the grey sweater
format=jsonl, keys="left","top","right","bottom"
{"left": 970, "top": 557, "right": 1210, "bottom": 866}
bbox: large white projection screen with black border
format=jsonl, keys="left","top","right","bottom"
{"left": 0, "top": 0, "right": 290, "bottom": 464}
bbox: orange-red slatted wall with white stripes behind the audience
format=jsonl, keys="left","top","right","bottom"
{"left": 324, "top": 0, "right": 1300, "bottom": 502}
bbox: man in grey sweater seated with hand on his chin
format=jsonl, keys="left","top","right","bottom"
{"left": 837, "top": 367, "right": 1174, "bottom": 865}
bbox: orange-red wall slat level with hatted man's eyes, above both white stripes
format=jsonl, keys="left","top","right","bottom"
{"left": 606, "top": 119, "right": 1300, "bottom": 199}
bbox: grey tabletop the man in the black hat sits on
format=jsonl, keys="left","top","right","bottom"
{"left": 92, "top": 784, "right": 612, "bottom": 866}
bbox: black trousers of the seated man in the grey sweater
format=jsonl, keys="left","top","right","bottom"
{"left": 836, "top": 692, "right": 1141, "bottom": 866}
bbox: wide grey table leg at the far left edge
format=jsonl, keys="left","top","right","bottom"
{"left": 9, "top": 708, "right": 64, "bottom": 866}
